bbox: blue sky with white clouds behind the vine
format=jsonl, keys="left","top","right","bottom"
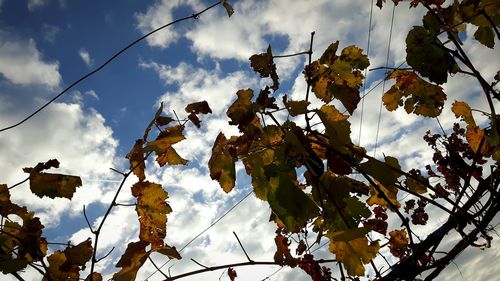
{"left": 0, "top": 0, "right": 500, "bottom": 281}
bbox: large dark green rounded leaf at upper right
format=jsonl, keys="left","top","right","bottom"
{"left": 406, "top": 26, "right": 456, "bottom": 84}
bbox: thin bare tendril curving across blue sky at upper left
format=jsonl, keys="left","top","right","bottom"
{"left": 0, "top": 1, "right": 222, "bottom": 132}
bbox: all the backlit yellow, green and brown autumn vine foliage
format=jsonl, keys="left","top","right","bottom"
{"left": 0, "top": 0, "right": 500, "bottom": 281}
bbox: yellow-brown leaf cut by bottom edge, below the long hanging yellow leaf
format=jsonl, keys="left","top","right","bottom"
{"left": 113, "top": 241, "right": 150, "bottom": 281}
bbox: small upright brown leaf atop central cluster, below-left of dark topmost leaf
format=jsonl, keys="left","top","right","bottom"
{"left": 226, "top": 89, "right": 255, "bottom": 131}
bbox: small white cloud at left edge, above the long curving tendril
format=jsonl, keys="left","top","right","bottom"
{"left": 0, "top": 30, "right": 61, "bottom": 88}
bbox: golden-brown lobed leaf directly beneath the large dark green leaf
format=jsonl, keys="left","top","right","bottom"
{"left": 382, "top": 70, "right": 446, "bottom": 117}
